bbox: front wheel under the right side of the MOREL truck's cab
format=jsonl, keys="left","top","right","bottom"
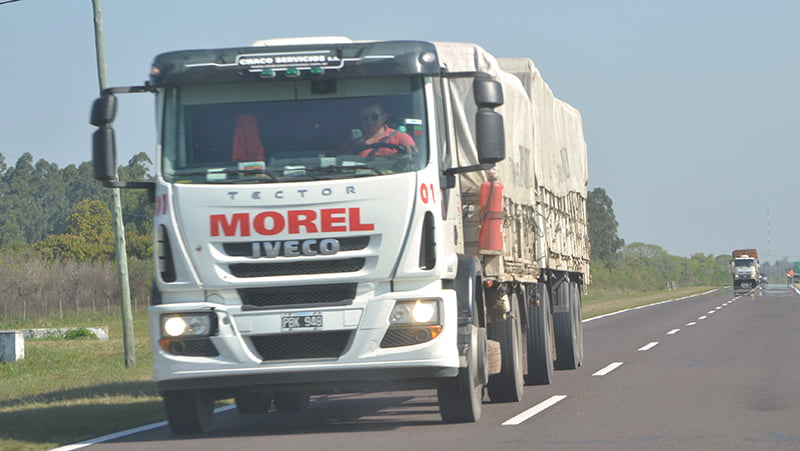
{"left": 436, "top": 324, "right": 486, "bottom": 423}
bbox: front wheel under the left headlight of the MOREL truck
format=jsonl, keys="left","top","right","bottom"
{"left": 164, "top": 390, "right": 214, "bottom": 434}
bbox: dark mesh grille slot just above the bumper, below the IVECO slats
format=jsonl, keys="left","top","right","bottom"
{"left": 236, "top": 283, "right": 356, "bottom": 307}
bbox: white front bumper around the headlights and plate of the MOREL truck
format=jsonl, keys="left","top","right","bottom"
{"left": 150, "top": 289, "right": 460, "bottom": 393}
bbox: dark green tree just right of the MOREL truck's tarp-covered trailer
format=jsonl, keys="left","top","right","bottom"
{"left": 586, "top": 188, "right": 625, "bottom": 263}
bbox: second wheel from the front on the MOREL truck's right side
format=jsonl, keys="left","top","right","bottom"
{"left": 486, "top": 293, "right": 525, "bottom": 402}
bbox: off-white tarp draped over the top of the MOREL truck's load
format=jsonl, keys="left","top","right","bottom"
{"left": 435, "top": 42, "right": 589, "bottom": 203}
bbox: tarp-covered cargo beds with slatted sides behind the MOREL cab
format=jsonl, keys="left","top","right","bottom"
{"left": 435, "top": 43, "right": 589, "bottom": 277}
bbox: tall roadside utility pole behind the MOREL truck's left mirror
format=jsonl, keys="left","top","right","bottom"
{"left": 92, "top": 0, "right": 136, "bottom": 368}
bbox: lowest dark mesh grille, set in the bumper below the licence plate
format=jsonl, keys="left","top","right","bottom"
{"left": 250, "top": 330, "right": 353, "bottom": 362}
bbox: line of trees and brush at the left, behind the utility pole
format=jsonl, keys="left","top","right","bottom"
{"left": 0, "top": 153, "right": 153, "bottom": 329}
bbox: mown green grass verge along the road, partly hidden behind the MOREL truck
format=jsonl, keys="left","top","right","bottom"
{"left": 0, "top": 287, "right": 713, "bottom": 451}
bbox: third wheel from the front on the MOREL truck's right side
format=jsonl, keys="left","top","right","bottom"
{"left": 525, "top": 283, "right": 554, "bottom": 385}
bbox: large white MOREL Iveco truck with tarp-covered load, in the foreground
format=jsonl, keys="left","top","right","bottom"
{"left": 91, "top": 38, "right": 589, "bottom": 433}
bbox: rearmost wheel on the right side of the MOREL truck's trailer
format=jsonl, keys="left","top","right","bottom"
{"left": 553, "top": 281, "right": 583, "bottom": 370}
